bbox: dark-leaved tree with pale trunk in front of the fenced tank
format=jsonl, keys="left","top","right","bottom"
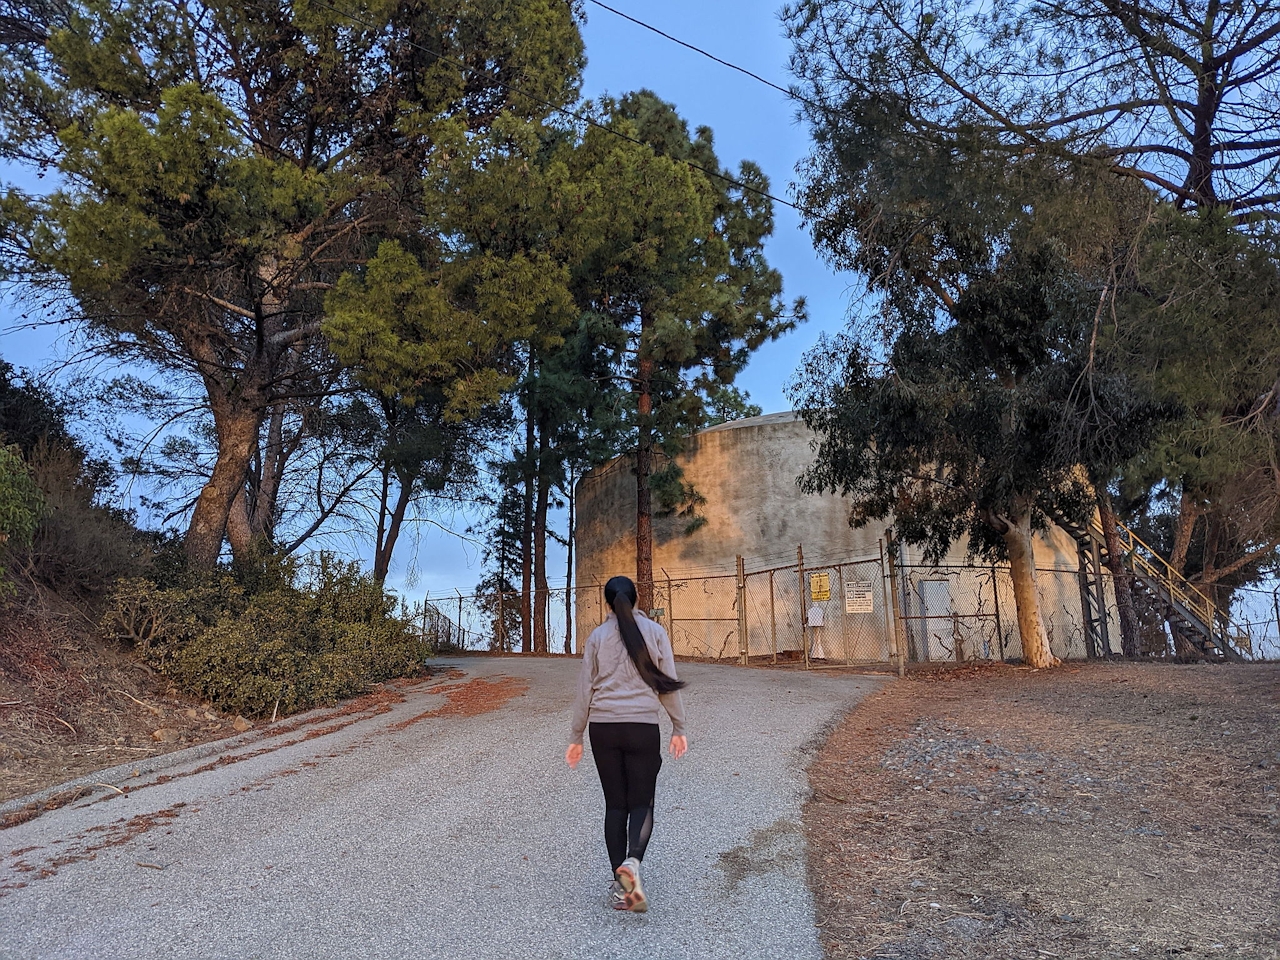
{"left": 792, "top": 231, "right": 1161, "bottom": 667}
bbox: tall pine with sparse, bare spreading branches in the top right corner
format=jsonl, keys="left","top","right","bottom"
{"left": 785, "top": 0, "right": 1280, "bottom": 665}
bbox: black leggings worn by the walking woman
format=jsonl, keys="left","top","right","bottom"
{"left": 590, "top": 723, "right": 662, "bottom": 870}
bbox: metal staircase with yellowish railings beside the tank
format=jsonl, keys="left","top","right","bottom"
{"left": 1053, "top": 513, "right": 1248, "bottom": 660}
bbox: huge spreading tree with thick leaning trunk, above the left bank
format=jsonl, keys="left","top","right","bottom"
{"left": 0, "top": 0, "right": 582, "bottom": 566}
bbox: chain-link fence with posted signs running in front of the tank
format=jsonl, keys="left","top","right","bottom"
{"left": 417, "top": 550, "right": 1280, "bottom": 667}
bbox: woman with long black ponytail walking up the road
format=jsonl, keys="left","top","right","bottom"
{"left": 564, "top": 577, "right": 689, "bottom": 913}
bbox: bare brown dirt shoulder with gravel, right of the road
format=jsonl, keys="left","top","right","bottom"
{"left": 804, "top": 663, "right": 1280, "bottom": 960}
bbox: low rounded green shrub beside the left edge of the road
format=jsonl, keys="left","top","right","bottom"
{"left": 104, "top": 553, "right": 429, "bottom": 716}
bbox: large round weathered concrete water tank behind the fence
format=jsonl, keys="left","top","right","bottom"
{"left": 575, "top": 412, "right": 1100, "bottom": 662}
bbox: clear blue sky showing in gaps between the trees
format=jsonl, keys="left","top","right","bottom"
{"left": 0, "top": 0, "right": 856, "bottom": 594}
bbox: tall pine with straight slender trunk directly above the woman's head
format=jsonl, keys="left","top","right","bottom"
{"left": 570, "top": 91, "right": 804, "bottom": 607}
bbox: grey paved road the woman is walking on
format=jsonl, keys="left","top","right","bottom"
{"left": 0, "top": 658, "right": 881, "bottom": 960}
